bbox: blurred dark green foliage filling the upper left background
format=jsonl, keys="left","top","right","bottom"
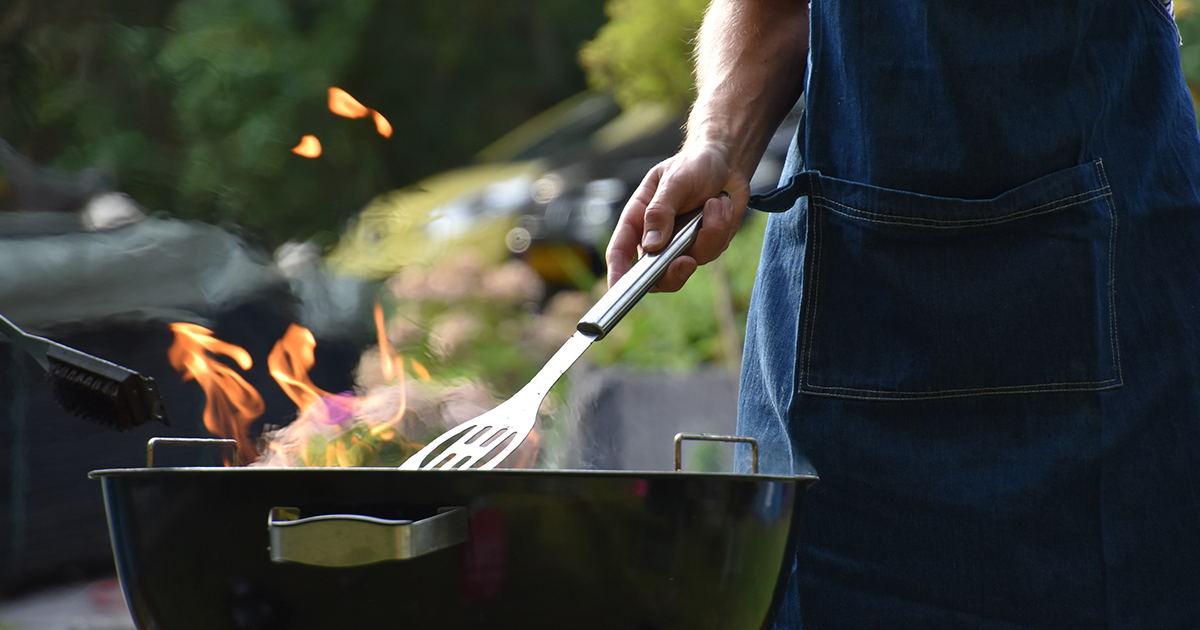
{"left": 0, "top": 0, "right": 604, "bottom": 244}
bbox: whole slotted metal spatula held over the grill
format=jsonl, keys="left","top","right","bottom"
{"left": 400, "top": 210, "right": 701, "bottom": 470}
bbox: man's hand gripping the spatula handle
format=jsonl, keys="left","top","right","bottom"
{"left": 605, "top": 145, "right": 750, "bottom": 290}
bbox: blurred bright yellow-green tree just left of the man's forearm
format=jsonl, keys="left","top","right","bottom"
{"left": 580, "top": 0, "right": 708, "bottom": 114}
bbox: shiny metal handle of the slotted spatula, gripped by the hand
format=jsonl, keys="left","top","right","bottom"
{"left": 576, "top": 210, "right": 701, "bottom": 340}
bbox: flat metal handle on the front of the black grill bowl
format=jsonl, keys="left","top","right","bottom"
{"left": 266, "top": 508, "right": 467, "bottom": 566}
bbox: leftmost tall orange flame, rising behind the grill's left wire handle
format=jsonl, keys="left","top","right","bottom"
{"left": 167, "top": 323, "right": 264, "bottom": 464}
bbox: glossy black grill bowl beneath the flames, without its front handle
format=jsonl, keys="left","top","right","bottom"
{"left": 91, "top": 468, "right": 816, "bottom": 630}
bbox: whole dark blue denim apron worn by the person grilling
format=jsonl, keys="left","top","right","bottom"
{"left": 739, "top": 0, "right": 1200, "bottom": 630}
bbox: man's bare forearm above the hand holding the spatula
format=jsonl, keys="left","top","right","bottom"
{"left": 685, "top": 0, "right": 809, "bottom": 179}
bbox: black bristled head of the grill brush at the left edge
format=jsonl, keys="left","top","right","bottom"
{"left": 47, "top": 356, "right": 167, "bottom": 430}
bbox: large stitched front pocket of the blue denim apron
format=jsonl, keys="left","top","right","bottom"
{"left": 797, "top": 161, "right": 1121, "bottom": 400}
